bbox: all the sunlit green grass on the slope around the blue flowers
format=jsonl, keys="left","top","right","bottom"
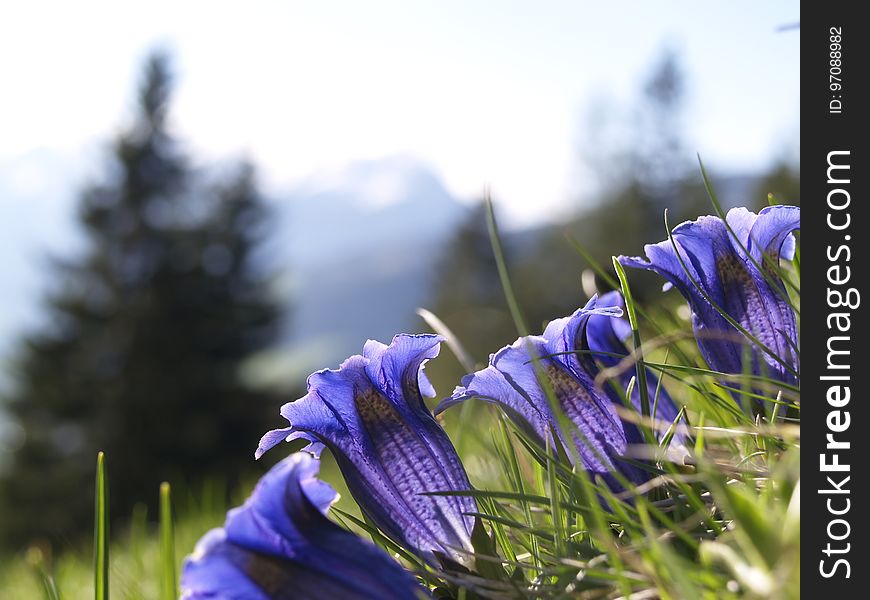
{"left": 0, "top": 196, "right": 800, "bottom": 600}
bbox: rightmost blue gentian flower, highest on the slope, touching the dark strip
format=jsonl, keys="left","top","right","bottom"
{"left": 619, "top": 206, "right": 800, "bottom": 384}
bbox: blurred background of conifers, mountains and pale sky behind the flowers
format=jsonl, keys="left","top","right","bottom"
{"left": 0, "top": 0, "right": 800, "bottom": 550}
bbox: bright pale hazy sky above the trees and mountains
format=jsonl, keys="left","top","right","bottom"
{"left": 0, "top": 0, "right": 799, "bottom": 225}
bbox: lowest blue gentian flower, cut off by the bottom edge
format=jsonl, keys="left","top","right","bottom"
{"left": 181, "top": 453, "right": 427, "bottom": 600}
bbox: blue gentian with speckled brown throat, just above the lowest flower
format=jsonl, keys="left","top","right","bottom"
{"left": 257, "top": 335, "right": 477, "bottom": 566}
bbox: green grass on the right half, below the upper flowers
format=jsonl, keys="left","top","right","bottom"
{"left": 424, "top": 185, "right": 800, "bottom": 599}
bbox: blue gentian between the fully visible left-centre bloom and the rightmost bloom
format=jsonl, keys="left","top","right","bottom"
{"left": 436, "top": 297, "right": 664, "bottom": 490}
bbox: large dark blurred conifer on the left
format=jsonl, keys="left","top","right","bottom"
{"left": 0, "top": 52, "right": 278, "bottom": 545}
